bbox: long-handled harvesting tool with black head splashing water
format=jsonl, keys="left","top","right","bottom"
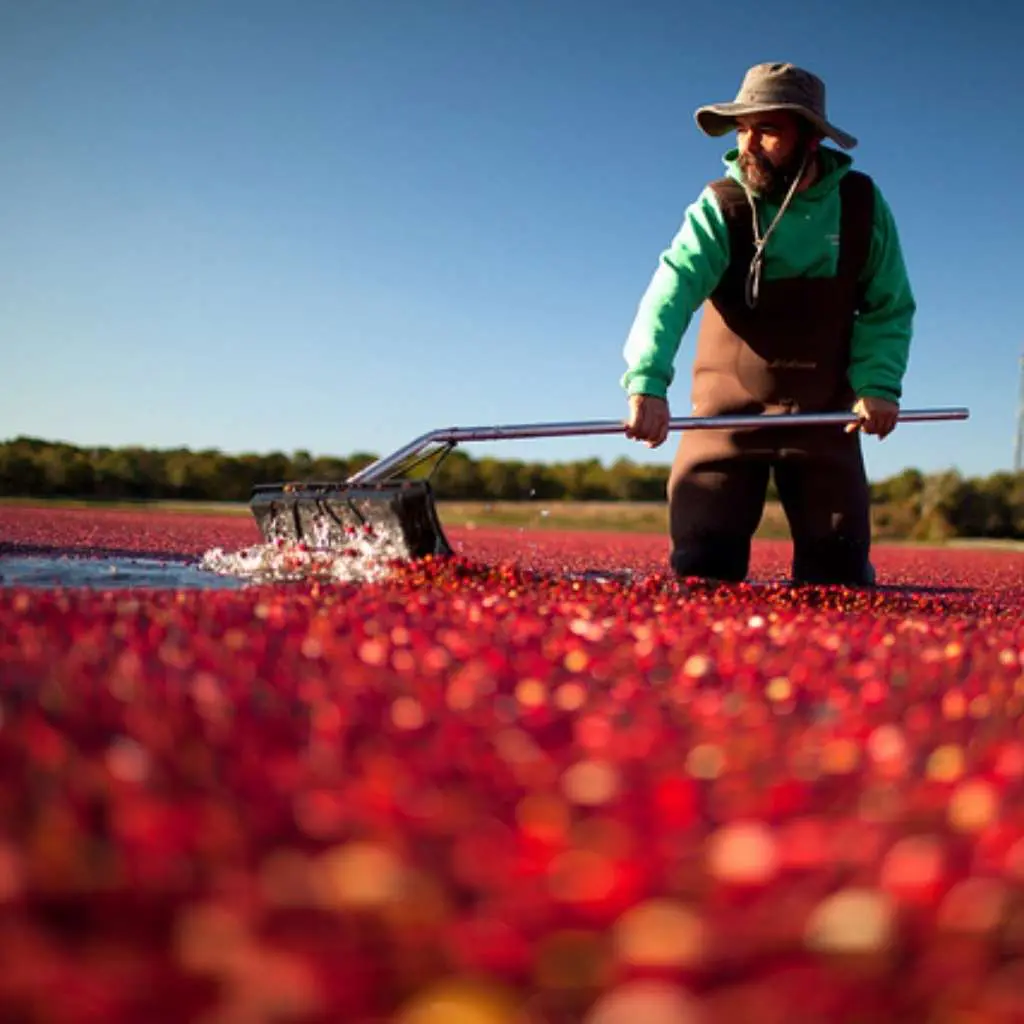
{"left": 250, "top": 408, "right": 970, "bottom": 558}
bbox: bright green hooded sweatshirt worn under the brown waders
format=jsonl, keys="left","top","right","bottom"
{"left": 622, "top": 147, "right": 916, "bottom": 401}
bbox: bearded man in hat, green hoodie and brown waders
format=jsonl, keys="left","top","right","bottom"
{"left": 622, "top": 63, "right": 915, "bottom": 586}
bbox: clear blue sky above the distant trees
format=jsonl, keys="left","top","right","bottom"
{"left": 0, "top": 0, "right": 1024, "bottom": 478}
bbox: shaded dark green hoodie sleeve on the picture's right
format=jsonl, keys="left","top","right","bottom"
{"left": 849, "top": 186, "right": 916, "bottom": 401}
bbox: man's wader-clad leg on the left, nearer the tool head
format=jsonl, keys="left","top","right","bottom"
{"left": 669, "top": 437, "right": 770, "bottom": 583}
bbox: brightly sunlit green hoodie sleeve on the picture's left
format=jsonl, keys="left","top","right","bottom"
{"left": 622, "top": 188, "right": 729, "bottom": 398}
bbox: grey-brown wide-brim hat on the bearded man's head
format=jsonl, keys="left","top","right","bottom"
{"left": 694, "top": 63, "right": 857, "bottom": 150}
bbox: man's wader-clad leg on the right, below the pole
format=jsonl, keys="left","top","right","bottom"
{"left": 775, "top": 432, "right": 874, "bottom": 587}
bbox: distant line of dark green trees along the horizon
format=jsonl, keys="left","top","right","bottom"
{"left": 0, "top": 437, "right": 1024, "bottom": 540}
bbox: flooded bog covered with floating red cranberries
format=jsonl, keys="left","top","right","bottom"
{"left": 0, "top": 507, "right": 1024, "bottom": 1024}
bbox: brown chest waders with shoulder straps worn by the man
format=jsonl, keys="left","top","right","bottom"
{"left": 669, "top": 171, "right": 873, "bottom": 586}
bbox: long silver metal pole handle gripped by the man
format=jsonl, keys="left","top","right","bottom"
{"left": 346, "top": 408, "right": 971, "bottom": 483}
